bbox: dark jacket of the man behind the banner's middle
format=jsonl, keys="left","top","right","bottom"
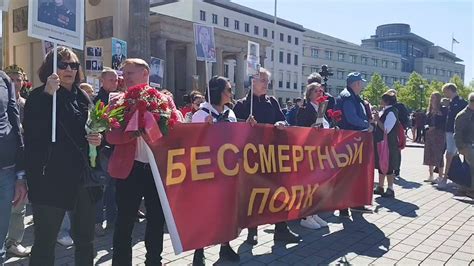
{"left": 234, "top": 92, "right": 286, "bottom": 125}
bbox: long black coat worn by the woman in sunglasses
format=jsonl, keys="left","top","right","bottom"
{"left": 23, "top": 85, "right": 98, "bottom": 210}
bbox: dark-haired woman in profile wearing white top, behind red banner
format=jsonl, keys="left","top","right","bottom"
{"left": 192, "top": 76, "right": 240, "bottom": 266}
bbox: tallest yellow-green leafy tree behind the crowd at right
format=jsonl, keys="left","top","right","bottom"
{"left": 398, "top": 72, "right": 429, "bottom": 110}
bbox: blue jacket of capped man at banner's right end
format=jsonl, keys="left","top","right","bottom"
{"left": 337, "top": 87, "right": 370, "bottom": 130}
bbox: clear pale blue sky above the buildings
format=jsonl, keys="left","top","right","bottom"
{"left": 232, "top": 0, "right": 474, "bottom": 84}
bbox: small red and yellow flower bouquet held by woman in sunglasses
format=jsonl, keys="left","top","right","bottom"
{"left": 86, "top": 101, "right": 125, "bottom": 167}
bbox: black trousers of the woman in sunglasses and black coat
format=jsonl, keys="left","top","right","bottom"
{"left": 30, "top": 188, "right": 95, "bottom": 266}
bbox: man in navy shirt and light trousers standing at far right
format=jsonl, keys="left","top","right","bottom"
{"left": 437, "top": 83, "right": 467, "bottom": 189}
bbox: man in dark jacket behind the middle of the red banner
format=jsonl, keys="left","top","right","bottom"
{"left": 234, "top": 67, "right": 301, "bottom": 245}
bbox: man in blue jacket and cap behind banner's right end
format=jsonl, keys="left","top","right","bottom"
{"left": 336, "top": 72, "right": 373, "bottom": 217}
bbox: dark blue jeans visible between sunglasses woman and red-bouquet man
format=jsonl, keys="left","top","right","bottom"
{"left": 95, "top": 178, "right": 117, "bottom": 227}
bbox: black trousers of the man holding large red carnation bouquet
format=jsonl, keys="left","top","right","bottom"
{"left": 112, "top": 161, "right": 165, "bottom": 266}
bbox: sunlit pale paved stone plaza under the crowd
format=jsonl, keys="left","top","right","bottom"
{"left": 6, "top": 147, "right": 474, "bottom": 265}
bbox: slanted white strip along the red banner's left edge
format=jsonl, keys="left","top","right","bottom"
{"left": 143, "top": 140, "right": 183, "bottom": 255}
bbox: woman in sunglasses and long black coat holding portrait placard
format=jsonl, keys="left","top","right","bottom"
{"left": 23, "top": 47, "right": 102, "bottom": 266}
